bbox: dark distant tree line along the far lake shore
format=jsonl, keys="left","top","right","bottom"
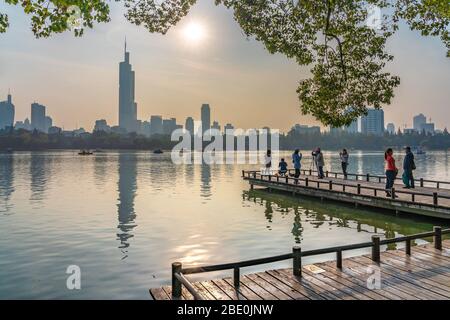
{"left": 0, "top": 129, "right": 450, "bottom": 151}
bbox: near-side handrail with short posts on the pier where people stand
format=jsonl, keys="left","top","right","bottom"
{"left": 242, "top": 170, "right": 450, "bottom": 207}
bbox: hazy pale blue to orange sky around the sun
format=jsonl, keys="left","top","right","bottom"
{"left": 0, "top": 0, "right": 450, "bottom": 131}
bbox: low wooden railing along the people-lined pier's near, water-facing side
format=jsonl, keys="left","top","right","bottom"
{"left": 242, "top": 170, "right": 450, "bottom": 207}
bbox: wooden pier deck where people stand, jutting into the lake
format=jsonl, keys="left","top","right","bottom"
{"left": 243, "top": 171, "right": 450, "bottom": 219}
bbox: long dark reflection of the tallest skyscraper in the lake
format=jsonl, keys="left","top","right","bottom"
{"left": 117, "top": 153, "right": 137, "bottom": 252}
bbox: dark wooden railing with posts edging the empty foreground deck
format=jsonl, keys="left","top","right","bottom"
{"left": 172, "top": 227, "right": 450, "bottom": 300}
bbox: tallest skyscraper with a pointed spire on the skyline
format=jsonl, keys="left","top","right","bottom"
{"left": 119, "top": 40, "right": 138, "bottom": 132}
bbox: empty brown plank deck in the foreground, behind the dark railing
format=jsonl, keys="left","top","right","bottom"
{"left": 150, "top": 240, "right": 450, "bottom": 300}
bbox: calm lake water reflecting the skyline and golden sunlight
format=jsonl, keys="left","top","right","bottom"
{"left": 0, "top": 151, "right": 450, "bottom": 299}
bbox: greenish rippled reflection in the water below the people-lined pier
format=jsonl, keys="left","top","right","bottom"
{"left": 242, "top": 190, "right": 446, "bottom": 249}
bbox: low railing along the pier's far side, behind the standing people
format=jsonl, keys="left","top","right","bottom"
{"left": 296, "top": 169, "right": 450, "bottom": 189}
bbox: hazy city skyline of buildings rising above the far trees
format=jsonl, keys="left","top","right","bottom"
{"left": 0, "top": 41, "right": 440, "bottom": 137}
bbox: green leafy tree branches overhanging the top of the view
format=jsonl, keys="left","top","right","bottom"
{"left": 0, "top": 0, "right": 450, "bottom": 127}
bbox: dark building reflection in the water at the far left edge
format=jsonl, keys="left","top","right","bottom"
{"left": 0, "top": 154, "right": 14, "bottom": 213}
